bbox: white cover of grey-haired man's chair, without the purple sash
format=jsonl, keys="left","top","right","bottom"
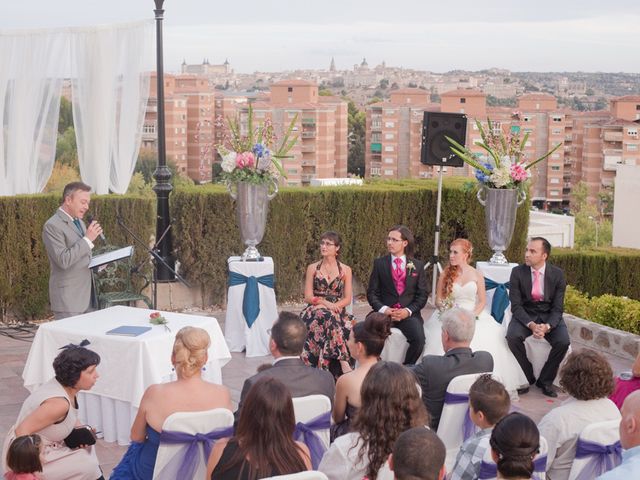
{"left": 437, "top": 372, "right": 500, "bottom": 471}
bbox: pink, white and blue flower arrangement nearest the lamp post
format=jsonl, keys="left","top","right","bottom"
{"left": 216, "top": 105, "right": 298, "bottom": 184}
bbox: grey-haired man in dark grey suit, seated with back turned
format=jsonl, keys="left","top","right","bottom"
{"left": 412, "top": 308, "right": 493, "bottom": 430}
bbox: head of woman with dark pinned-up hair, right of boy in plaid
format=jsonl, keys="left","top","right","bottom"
{"left": 489, "top": 412, "right": 540, "bottom": 480}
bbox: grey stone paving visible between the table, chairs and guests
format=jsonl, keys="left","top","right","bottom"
{"left": 0, "top": 301, "right": 631, "bottom": 478}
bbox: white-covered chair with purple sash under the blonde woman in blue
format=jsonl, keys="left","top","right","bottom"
{"left": 153, "top": 408, "right": 234, "bottom": 480}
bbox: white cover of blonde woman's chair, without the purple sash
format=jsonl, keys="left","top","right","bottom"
{"left": 153, "top": 408, "right": 233, "bottom": 480}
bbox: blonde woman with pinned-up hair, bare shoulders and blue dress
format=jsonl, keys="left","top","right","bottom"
{"left": 110, "top": 327, "right": 232, "bottom": 480}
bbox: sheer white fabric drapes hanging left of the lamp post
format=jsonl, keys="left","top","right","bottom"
{"left": 0, "top": 20, "right": 155, "bottom": 195}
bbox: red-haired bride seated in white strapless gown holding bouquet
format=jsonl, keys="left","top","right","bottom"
{"left": 424, "top": 238, "right": 529, "bottom": 393}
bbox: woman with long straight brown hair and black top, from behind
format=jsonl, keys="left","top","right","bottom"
{"left": 207, "top": 378, "right": 311, "bottom": 480}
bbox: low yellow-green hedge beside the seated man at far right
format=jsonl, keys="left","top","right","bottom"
{"left": 564, "top": 287, "right": 640, "bottom": 335}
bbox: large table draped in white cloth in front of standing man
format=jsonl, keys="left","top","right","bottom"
{"left": 22, "top": 306, "right": 231, "bottom": 445}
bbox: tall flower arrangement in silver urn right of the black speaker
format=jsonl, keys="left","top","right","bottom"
{"left": 446, "top": 118, "right": 561, "bottom": 191}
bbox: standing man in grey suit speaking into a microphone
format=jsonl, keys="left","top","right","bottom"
{"left": 42, "top": 182, "right": 102, "bottom": 320}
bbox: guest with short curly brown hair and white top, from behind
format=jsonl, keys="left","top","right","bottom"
{"left": 538, "top": 350, "right": 620, "bottom": 480}
